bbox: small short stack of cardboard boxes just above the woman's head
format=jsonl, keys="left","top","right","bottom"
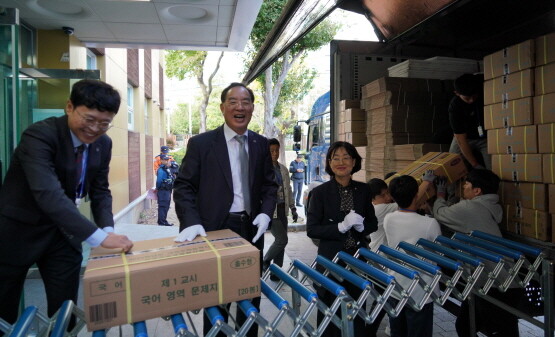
{"left": 337, "top": 100, "right": 366, "bottom": 146}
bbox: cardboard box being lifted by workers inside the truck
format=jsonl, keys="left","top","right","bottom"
{"left": 387, "top": 152, "right": 468, "bottom": 184}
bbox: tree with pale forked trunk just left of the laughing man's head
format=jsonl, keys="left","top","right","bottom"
{"left": 166, "top": 50, "right": 224, "bottom": 132}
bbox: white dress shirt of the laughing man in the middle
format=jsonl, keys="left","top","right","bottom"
{"left": 224, "top": 124, "right": 249, "bottom": 212}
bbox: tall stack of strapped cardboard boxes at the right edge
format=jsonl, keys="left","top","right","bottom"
{"left": 484, "top": 33, "right": 555, "bottom": 242}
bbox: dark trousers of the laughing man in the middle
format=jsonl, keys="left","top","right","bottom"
{"left": 203, "top": 214, "right": 264, "bottom": 337}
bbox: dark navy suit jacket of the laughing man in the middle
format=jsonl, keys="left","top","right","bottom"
{"left": 173, "top": 126, "right": 277, "bottom": 240}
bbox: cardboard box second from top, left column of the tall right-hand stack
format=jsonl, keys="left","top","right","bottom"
{"left": 484, "top": 69, "right": 534, "bottom": 105}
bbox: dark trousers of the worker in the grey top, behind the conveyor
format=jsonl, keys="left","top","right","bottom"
{"left": 455, "top": 289, "right": 524, "bottom": 337}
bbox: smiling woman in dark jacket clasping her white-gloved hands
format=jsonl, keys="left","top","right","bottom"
{"left": 307, "top": 142, "right": 378, "bottom": 336}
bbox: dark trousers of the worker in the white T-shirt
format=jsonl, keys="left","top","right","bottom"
{"left": 389, "top": 302, "right": 434, "bottom": 337}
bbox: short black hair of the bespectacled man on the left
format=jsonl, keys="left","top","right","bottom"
{"left": 69, "top": 80, "right": 121, "bottom": 114}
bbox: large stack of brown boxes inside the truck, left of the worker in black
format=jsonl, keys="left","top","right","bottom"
{"left": 360, "top": 77, "right": 453, "bottom": 178}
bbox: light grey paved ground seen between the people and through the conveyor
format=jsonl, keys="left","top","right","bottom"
{"left": 20, "top": 196, "right": 543, "bottom": 337}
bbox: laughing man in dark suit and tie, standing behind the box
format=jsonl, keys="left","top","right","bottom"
{"left": 173, "top": 83, "right": 277, "bottom": 336}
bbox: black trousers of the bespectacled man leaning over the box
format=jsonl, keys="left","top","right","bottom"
{"left": 0, "top": 224, "right": 83, "bottom": 324}
